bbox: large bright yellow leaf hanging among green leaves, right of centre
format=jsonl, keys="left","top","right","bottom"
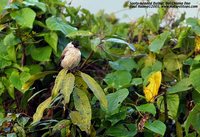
{"left": 144, "top": 71, "right": 162, "bottom": 102}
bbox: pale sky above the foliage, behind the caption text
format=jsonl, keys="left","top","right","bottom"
{"left": 72, "top": 0, "right": 200, "bottom": 22}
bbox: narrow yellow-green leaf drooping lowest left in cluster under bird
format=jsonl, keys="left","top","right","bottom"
{"left": 32, "top": 97, "right": 52, "bottom": 123}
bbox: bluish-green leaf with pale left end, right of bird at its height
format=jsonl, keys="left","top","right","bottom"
{"left": 109, "top": 58, "right": 138, "bottom": 71}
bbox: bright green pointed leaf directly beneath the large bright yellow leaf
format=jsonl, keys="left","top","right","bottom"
{"left": 136, "top": 103, "right": 156, "bottom": 116}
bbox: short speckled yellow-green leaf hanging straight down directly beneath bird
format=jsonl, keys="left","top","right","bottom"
{"left": 60, "top": 73, "right": 75, "bottom": 104}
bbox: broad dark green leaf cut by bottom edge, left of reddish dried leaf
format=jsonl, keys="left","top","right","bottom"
{"left": 105, "top": 124, "right": 137, "bottom": 137}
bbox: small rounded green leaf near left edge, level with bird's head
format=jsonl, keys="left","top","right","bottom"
{"left": 3, "top": 33, "right": 20, "bottom": 46}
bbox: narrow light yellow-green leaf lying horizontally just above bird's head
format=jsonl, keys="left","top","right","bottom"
{"left": 67, "top": 30, "right": 93, "bottom": 38}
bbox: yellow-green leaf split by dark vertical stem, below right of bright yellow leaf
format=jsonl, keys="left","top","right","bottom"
{"left": 157, "top": 94, "right": 179, "bottom": 119}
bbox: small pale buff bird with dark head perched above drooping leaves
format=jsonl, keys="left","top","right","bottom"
{"left": 61, "top": 42, "right": 81, "bottom": 70}
